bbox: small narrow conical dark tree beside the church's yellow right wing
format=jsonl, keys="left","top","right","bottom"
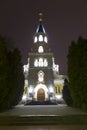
{"left": 62, "top": 79, "right": 73, "bottom": 106}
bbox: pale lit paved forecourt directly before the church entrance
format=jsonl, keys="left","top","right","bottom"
{"left": 0, "top": 104, "right": 87, "bottom": 116}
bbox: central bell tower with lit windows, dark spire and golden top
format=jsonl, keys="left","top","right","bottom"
{"left": 28, "top": 13, "right": 54, "bottom": 101}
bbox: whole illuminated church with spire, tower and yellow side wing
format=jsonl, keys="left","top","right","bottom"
{"left": 22, "top": 13, "right": 64, "bottom": 103}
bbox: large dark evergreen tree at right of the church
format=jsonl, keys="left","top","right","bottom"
{"left": 68, "top": 37, "right": 87, "bottom": 109}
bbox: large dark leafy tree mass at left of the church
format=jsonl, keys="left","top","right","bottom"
{"left": 0, "top": 36, "right": 24, "bottom": 110}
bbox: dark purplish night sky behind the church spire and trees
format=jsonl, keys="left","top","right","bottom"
{"left": 0, "top": 0, "right": 87, "bottom": 74}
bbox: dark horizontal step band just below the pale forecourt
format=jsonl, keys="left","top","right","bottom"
{"left": 0, "top": 115, "right": 87, "bottom": 125}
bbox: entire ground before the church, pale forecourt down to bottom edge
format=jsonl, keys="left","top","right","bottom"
{"left": 0, "top": 104, "right": 87, "bottom": 130}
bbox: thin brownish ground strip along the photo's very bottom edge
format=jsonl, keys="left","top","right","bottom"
{"left": 0, "top": 125, "right": 87, "bottom": 130}
